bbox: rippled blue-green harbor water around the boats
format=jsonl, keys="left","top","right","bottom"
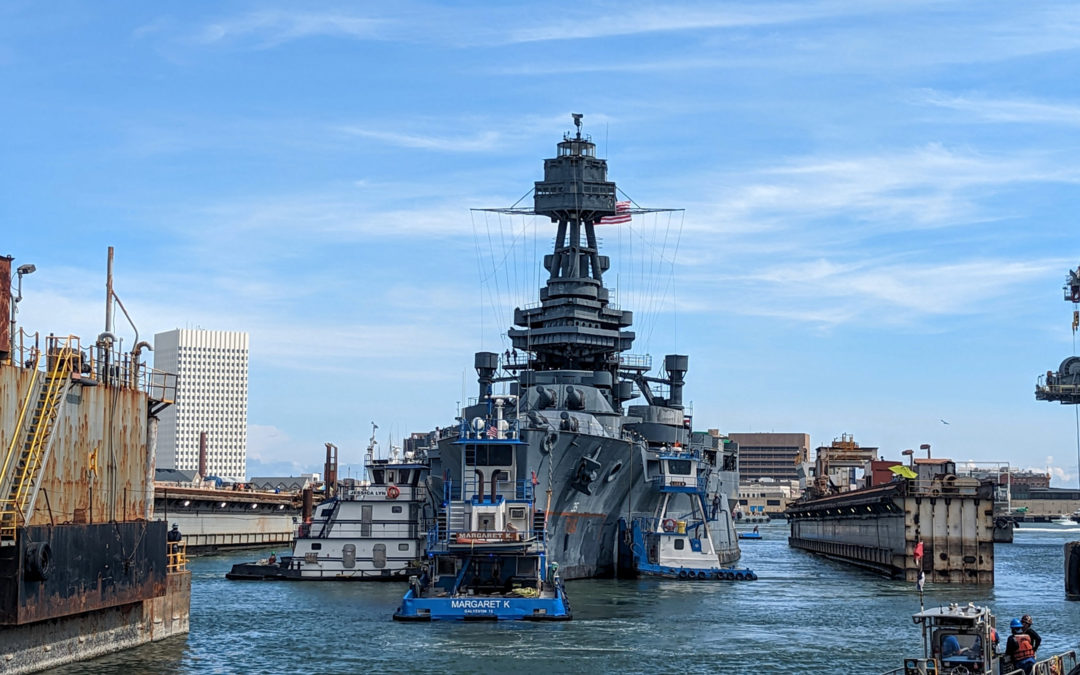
{"left": 52, "top": 522, "right": 1080, "bottom": 675}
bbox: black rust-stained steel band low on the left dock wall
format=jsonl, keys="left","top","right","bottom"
{"left": 0, "top": 521, "right": 166, "bottom": 625}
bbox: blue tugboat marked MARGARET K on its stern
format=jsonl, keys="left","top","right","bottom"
{"left": 394, "top": 396, "right": 571, "bottom": 621}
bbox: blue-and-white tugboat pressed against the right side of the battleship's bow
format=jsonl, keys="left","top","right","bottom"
{"left": 619, "top": 446, "right": 757, "bottom": 581}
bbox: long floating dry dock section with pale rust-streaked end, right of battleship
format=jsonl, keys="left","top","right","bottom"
{"left": 785, "top": 440, "right": 995, "bottom": 584}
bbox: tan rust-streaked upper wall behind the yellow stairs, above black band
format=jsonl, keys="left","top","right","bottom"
{"left": 0, "top": 364, "right": 152, "bottom": 525}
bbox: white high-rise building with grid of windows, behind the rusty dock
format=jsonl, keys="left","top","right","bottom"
{"left": 153, "top": 328, "right": 247, "bottom": 480}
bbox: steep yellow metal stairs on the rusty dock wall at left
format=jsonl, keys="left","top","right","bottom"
{"left": 0, "top": 336, "right": 80, "bottom": 546}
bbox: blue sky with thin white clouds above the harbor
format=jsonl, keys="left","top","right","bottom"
{"left": 0, "top": 1, "right": 1080, "bottom": 485}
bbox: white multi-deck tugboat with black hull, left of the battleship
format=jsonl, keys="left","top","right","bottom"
{"left": 226, "top": 426, "right": 434, "bottom": 581}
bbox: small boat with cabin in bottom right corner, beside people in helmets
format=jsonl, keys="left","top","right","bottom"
{"left": 882, "top": 603, "right": 1077, "bottom": 675}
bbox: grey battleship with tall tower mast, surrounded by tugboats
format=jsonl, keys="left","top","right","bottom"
{"left": 431, "top": 114, "right": 739, "bottom": 579}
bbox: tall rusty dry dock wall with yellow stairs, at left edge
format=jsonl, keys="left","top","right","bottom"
{"left": 0, "top": 248, "right": 191, "bottom": 673}
